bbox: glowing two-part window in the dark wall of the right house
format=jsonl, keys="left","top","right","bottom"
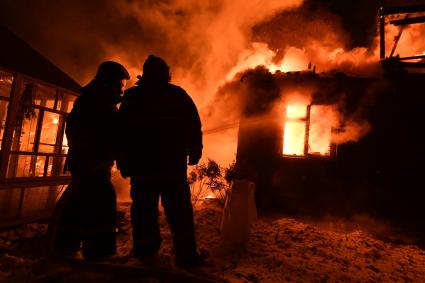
{"left": 282, "top": 104, "right": 338, "bottom": 157}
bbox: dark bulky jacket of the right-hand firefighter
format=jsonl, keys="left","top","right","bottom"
{"left": 117, "top": 80, "right": 202, "bottom": 179}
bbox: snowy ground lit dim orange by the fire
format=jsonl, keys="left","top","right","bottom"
{"left": 0, "top": 202, "right": 425, "bottom": 283}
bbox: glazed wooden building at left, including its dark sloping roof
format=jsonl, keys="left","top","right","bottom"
{"left": 0, "top": 26, "right": 80, "bottom": 227}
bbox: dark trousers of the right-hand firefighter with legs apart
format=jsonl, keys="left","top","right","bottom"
{"left": 131, "top": 177, "right": 197, "bottom": 261}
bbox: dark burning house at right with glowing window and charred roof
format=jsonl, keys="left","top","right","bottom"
{"left": 236, "top": 6, "right": 425, "bottom": 230}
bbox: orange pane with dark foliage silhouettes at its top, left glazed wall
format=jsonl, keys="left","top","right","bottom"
{"left": 12, "top": 109, "right": 39, "bottom": 151}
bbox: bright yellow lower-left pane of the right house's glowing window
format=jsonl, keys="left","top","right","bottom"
{"left": 283, "top": 122, "right": 305, "bottom": 155}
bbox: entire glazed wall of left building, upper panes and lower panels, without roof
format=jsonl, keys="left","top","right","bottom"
{"left": 0, "top": 68, "right": 77, "bottom": 227}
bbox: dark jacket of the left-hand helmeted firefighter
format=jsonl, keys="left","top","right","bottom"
{"left": 65, "top": 81, "right": 118, "bottom": 176}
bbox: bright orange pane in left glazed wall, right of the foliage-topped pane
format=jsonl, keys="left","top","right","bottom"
{"left": 38, "top": 111, "right": 60, "bottom": 153}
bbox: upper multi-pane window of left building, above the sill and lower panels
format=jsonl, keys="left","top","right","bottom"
{"left": 6, "top": 80, "right": 76, "bottom": 178}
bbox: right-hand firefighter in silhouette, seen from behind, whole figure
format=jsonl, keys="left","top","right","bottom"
{"left": 117, "top": 55, "right": 203, "bottom": 268}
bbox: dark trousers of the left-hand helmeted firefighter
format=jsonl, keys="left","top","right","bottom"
{"left": 55, "top": 175, "right": 116, "bottom": 260}
